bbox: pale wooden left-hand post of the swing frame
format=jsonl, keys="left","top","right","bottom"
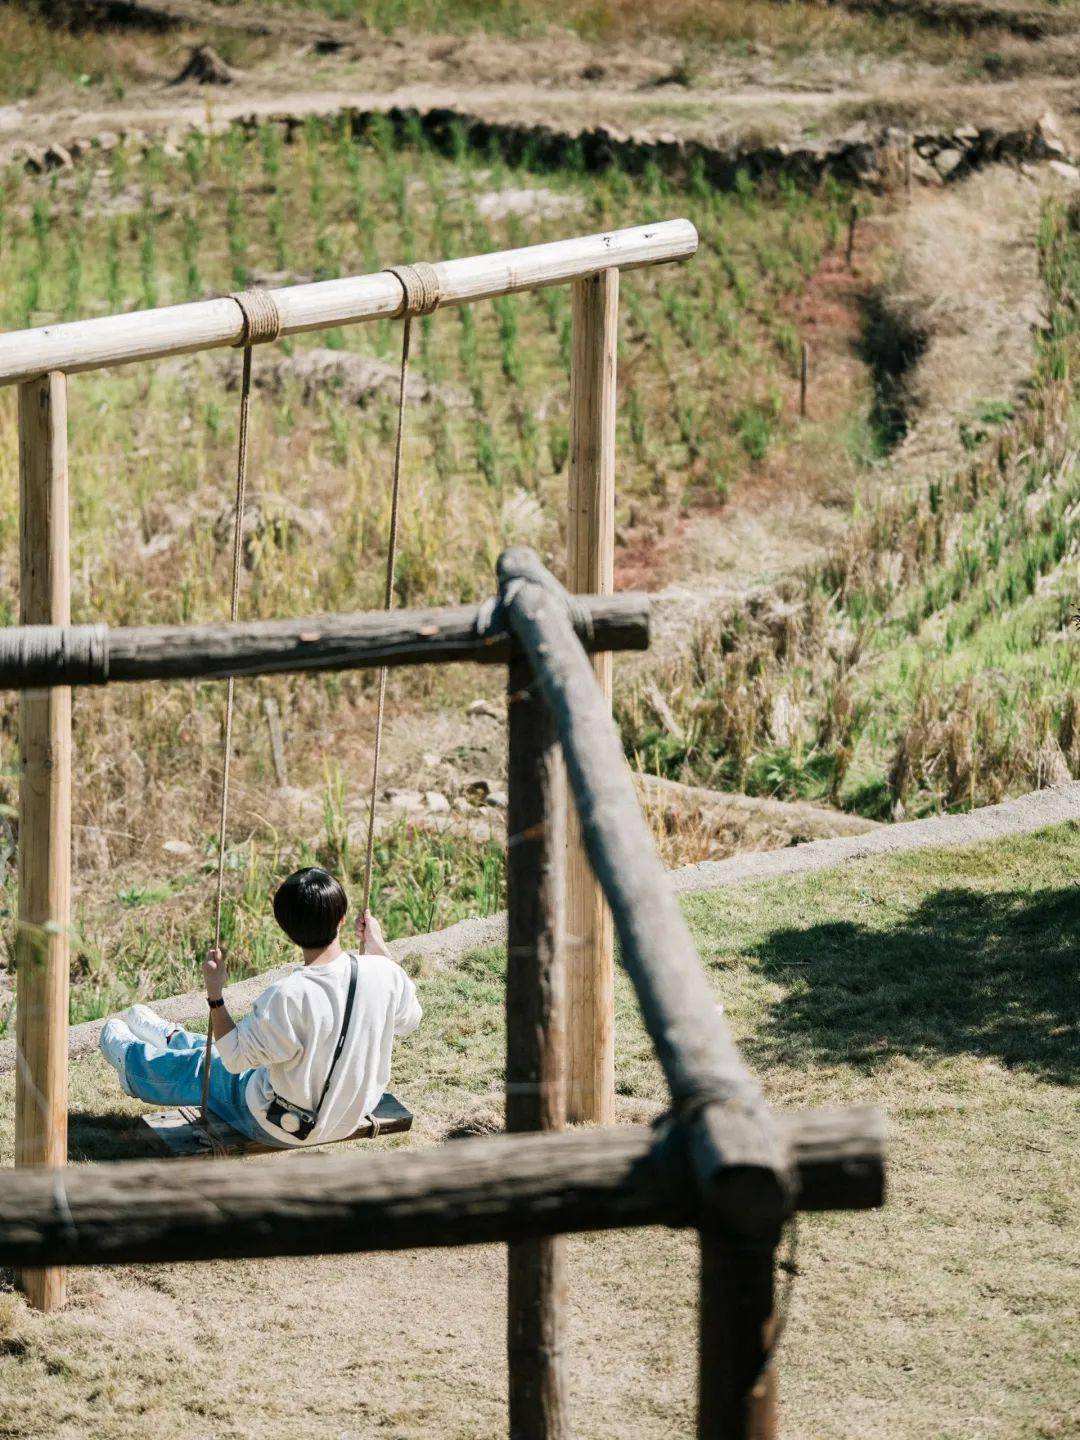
{"left": 14, "top": 373, "right": 71, "bottom": 1310}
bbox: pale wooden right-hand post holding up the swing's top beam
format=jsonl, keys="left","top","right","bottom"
{"left": 566, "top": 269, "right": 619, "bottom": 1125}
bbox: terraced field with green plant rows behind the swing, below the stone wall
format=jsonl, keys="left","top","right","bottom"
{"left": 0, "top": 121, "right": 876, "bottom": 1014}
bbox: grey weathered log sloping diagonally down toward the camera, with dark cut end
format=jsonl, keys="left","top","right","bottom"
{"left": 498, "top": 549, "right": 791, "bottom": 1234}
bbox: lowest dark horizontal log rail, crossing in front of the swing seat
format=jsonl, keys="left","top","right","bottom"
{"left": 0, "top": 1106, "right": 884, "bottom": 1266}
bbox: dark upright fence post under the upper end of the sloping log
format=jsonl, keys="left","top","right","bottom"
{"left": 507, "top": 660, "right": 567, "bottom": 1440}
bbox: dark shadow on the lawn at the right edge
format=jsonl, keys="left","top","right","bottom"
{"left": 746, "top": 887, "right": 1080, "bottom": 1083}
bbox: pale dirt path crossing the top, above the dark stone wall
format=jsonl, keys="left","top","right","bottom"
{"left": 0, "top": 16, "right": 1080, "bottom": 164}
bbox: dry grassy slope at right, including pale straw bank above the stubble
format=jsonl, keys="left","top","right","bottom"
{"left": 622, "top": 185, "right": 1080, "bottom": 818}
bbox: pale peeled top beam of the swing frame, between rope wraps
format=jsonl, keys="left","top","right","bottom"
{"left": 0, "top": 220, "right": 697, "bottom": 384}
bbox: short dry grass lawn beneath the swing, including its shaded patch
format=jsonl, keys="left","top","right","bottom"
{"left": 0, "top": 825, "right": 1080, "bottom": 1440}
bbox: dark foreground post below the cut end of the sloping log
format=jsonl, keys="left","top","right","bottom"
{"left": 697, "top": 1230, "right": 776, "bottom": 1440}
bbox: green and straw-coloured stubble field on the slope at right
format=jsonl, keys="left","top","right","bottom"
{"left": 625, "top": 202, "right": 1080, "bottom": 818}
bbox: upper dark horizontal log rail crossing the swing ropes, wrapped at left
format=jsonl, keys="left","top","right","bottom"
{"left": 0, "top": 593, "right": 649, "bottom": 690}
